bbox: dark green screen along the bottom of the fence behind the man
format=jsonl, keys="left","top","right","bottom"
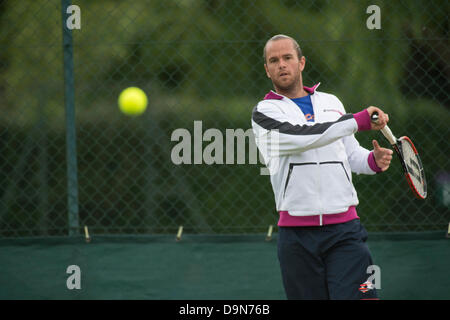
{"left": 0, "top": 232, "right": 450, "bottom": 300}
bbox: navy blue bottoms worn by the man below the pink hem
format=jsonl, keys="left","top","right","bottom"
{"left": 278, "top": 219, "right": 377, "bottom": 300}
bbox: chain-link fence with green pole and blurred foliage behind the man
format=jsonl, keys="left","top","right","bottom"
{"left": 0, "top": 0, "right": 450, "bottom": 237}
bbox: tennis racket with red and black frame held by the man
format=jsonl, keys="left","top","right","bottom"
{"left": 371, "top": 112, "right": 427, "bottom": 199}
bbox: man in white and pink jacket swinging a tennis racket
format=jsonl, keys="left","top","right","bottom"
{"left": 252, "top": 35, "right": 392, "bottom": 299}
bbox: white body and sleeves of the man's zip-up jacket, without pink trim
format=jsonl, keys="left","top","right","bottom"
{"left": 252, "top": 85, "right": 376, "bottom": 216}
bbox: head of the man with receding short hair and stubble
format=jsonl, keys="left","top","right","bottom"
{"left": 264, "top": 39, "right": 305, "bottom": 91}
